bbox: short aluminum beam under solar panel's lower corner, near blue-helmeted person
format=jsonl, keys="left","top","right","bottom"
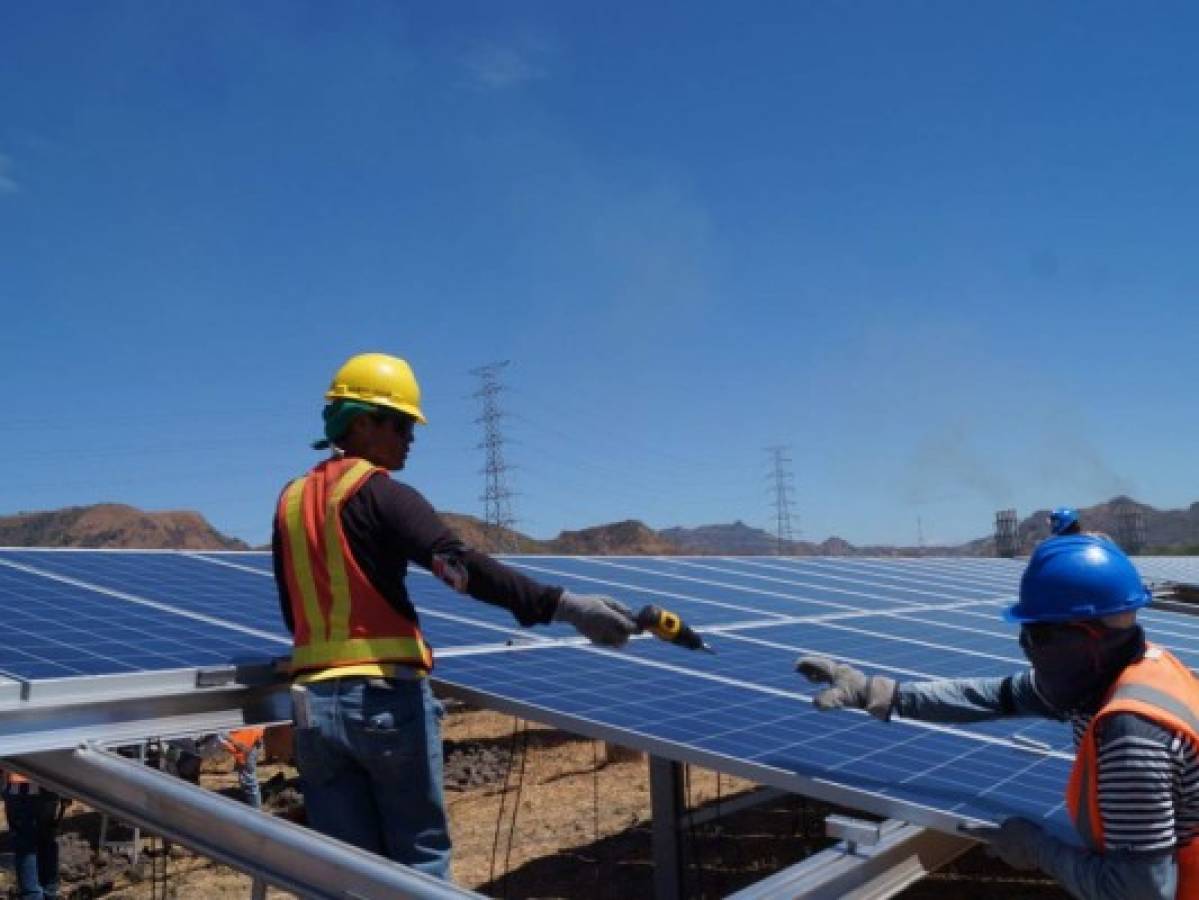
{"left": 725, "top": 820, "right": 976, "bottom": 900}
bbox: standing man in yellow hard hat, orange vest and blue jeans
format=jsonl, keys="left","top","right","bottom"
{"left": 272, "top": 354, "right": 638, "bottom": 877}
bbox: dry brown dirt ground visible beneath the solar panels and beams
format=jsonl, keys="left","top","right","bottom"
{"left": 0, "top": 708, "right": 1067, "bottom": 900}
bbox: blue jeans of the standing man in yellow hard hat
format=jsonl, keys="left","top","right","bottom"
{"left": 295, "top": 677, "right": 450, "bottom": 878}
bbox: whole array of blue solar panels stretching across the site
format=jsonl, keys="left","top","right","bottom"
{"left": 7, "top": 549, "right": 1199, "bottom": 833}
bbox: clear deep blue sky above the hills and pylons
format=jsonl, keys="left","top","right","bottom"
{"left": 0, "top": 1, "right": 1199, "bottom": 543}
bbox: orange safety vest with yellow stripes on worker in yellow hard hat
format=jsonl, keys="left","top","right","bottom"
{"left": 276, "top": 458, "right": 433, "bottom": 672}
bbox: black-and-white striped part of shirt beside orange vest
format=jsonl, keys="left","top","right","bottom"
{"left": 1071, "top": 713, "right": 1199, "bottom": 853}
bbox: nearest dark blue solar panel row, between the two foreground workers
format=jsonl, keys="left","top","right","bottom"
{"left": 440, "top": 648, "right": 1073, "bottom": 838}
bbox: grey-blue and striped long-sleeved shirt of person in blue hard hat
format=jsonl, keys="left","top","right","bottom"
{"left": 894, "top": 670, "right": 1184, "bottom": 900}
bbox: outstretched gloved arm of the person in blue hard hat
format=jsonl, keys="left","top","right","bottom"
{"left": 795, "top": 656, "right": 1059, "bottom": 721}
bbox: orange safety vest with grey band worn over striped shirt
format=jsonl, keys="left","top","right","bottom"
{"left": 1066, "top": 645, "right": 1199, "bottom": 900}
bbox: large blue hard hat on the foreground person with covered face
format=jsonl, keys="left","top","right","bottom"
{"left": 1004, "top": 534, "right": 1152, "bottom": 623}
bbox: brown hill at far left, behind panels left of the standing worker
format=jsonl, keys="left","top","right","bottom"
{"left": 0, "top": 503, "right": 248, "bottom": 550}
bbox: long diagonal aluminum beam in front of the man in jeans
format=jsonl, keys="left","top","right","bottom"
{"left": 5, "top": 747, "right": 480, "bottom": 900}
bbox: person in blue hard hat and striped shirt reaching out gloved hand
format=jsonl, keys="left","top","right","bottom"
{"left": 796, "top": 534, "right": 1199, "bottom": 900}
